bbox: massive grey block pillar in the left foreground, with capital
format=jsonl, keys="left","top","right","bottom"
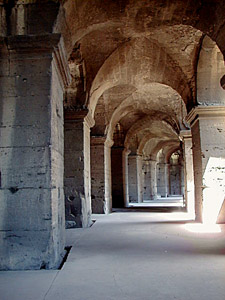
{"left": 0, "top": 34, "right": 69, "bottom": 270}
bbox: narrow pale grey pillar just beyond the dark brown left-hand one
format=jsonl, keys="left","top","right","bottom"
{"left": 128, "top": 155, "right": 138, "bottom": 202}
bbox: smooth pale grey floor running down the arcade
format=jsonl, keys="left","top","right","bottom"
{"left": 0, "top": 212, "right": 225, "bottom": 300}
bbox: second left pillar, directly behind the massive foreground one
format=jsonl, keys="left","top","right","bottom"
{"left": 64, "top": 110, "right": 94, "bottom": 227}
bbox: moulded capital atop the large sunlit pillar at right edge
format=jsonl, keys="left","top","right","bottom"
{"left": 186, "top": 105, "right": 225, "bottom": 127}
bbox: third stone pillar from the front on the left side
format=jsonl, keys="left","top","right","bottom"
{"left": 91, "top": 136, "right": 112, "bottom": 214}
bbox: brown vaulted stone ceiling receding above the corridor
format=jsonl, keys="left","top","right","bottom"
{"left": 56, "top": 0, "right": 224, "bottom": 158}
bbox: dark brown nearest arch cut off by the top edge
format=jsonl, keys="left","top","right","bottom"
{"left": 58, "top": 0, "right": 225, "bottom": 59}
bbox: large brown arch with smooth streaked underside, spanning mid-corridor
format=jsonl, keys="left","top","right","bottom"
{"left": 89, "top": 38, "right": 192, "bottom": 114}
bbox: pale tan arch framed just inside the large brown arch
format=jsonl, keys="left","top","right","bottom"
{"left": 105, "top": 83, "right": 187, "bottom": 139}
